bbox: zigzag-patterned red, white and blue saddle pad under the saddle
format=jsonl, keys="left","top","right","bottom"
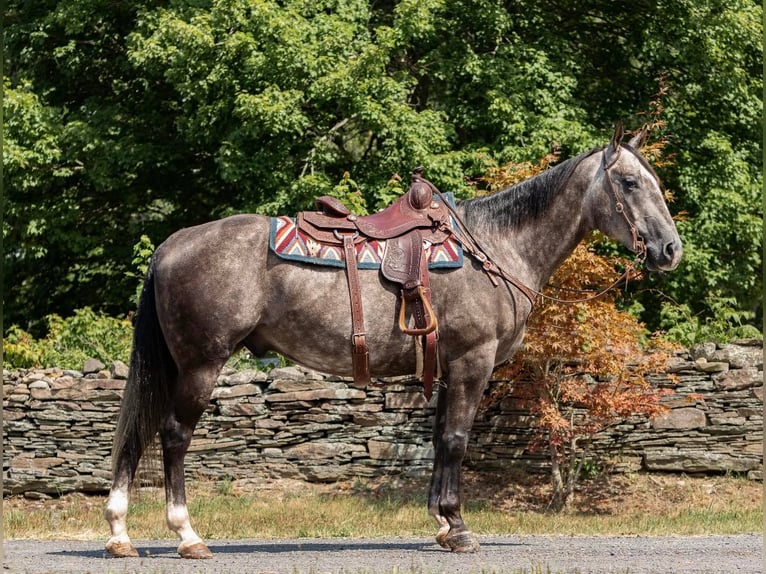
{"left": 269, "top": 216, "right": 463, "bottom": 269}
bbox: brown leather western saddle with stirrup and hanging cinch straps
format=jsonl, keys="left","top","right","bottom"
{"left": 297, "top": 168, "right": 453, "bottom": 399}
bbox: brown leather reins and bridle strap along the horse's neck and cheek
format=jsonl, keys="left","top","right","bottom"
{"left": 432, "top": 145, "right": 646, "bottom": 307}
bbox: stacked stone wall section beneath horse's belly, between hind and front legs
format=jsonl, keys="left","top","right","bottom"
{"left": 186, "top": 367, "right": 433, "bottom": 488}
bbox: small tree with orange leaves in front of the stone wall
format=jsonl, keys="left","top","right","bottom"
{"left": 501, "top": 244, "right": 670, "bottom": 512}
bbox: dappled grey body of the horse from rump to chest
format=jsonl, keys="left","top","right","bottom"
{"left": 149, "top": 215, "right": 526, "bottom": 376}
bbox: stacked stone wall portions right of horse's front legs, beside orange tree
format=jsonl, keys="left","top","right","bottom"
{"left": 469, "top": 340, "right": 763, "bottom": 480}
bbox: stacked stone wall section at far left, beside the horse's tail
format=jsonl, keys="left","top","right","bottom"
{"left": 3, "top": 361, "right": 127, "bottom": 493}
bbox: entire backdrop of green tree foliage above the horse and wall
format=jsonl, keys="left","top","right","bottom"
{"left": 3, "top": 0, "right": 763, "bottom": 336}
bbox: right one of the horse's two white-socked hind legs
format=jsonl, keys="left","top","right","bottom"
{"left": 160, "top": 364, "right": 221, "bottom": 558}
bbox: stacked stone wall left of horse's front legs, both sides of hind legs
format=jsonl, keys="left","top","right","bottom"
{"left": 3, "top": 365, "right": 433, "bottom": 493}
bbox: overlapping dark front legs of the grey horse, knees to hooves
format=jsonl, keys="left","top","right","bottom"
{"left": 428, "top": 364, "right": 491, "bottom": 552}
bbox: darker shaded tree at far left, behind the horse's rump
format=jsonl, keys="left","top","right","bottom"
{"left": 3, "top": 0, "right": 192, "bottom": 328}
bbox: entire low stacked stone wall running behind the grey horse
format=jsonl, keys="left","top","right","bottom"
{"left": 3, "top": 341, "right": 763, "bottom": 493}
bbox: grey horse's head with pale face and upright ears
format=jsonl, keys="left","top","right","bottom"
{"left": 591, "top": 126, "right": 683, "bottom": 271}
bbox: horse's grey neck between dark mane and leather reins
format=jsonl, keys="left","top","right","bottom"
{"left": 460, "top": 162, "right": 592, "bottom": 290}
